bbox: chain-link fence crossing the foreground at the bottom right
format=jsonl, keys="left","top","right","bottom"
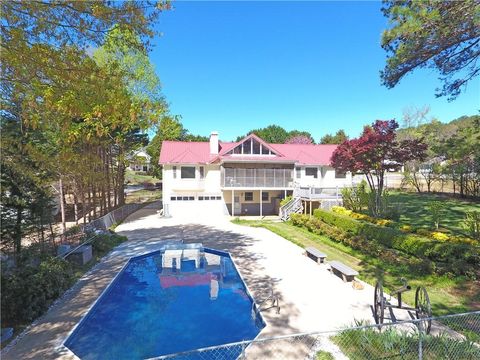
{"left": 153, "top": 311, "right": 480, "bottom": 360}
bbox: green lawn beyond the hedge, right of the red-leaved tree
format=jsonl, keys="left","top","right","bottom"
{"left": 390, "top": 191, "right": 480, "bottom": 233}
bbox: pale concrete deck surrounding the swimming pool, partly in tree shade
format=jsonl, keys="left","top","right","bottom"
{"left": 2, "top": 203, "right": 401, "bottom": 359}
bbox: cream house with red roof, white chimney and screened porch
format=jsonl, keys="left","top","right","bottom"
{"left": 159, "top": 132, "right": 351, "bottom": 216}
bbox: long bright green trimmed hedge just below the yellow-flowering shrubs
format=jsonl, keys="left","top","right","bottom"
{"left": 314, "top": 209, "right": 480, "bottom": 276}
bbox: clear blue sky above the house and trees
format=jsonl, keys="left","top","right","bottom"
{"left": 150, "top": 1, "right": 480, "bottom": 141}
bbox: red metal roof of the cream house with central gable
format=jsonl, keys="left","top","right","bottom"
{"left": 159, "top": 135, "right": 337, "bottom": 165}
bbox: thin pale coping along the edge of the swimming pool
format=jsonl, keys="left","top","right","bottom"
{"left": 59, "top": 243, "right": 269, "bottom": 360}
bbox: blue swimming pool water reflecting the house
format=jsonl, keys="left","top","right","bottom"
{"left": 65, "top": 248, "right": 264, "bottom": 359}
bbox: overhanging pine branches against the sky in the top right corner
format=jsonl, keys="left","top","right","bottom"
{"left": 381, "top": 0, "right": 480, "bottom": 100}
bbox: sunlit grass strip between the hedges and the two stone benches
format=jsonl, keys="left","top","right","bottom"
{"left": 234, "top": 220, "right": 480, "bottom": 315}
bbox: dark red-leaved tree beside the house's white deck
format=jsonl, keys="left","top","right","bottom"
{"left": 330, "top": 120, "right": 427, "bottom": 217}
